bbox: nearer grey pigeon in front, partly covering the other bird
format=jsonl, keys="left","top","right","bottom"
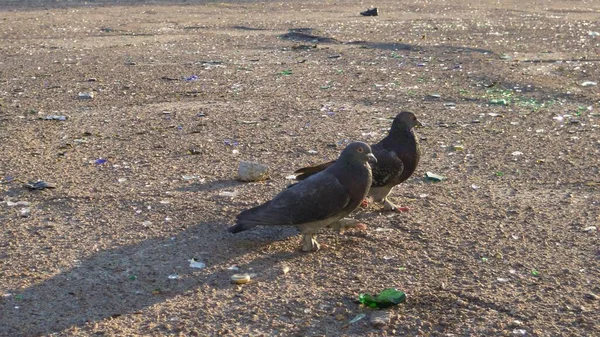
{"left": 227, "top": 142, "right": 377, "bottom": 251}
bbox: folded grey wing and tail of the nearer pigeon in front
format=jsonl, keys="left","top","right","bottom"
{"left": 236, "top": 172, "right": 351, "bottom": 230}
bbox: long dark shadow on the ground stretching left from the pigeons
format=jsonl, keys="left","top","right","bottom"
{"left": 0, "top": 220, "right": 303, "bottom": 336}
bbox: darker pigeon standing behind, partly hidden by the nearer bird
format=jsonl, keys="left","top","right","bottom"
{"left": 294, "top": 111, "right": 422, "bottom": 212}
